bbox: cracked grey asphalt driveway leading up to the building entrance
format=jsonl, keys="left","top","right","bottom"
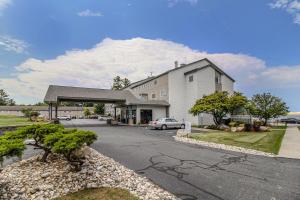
{"left": 79, "top": 126, "right": 300, "bottom": 200}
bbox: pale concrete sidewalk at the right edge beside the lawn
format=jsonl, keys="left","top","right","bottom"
{"left": 278, "top": 126, "right": 300, "bottom": 159}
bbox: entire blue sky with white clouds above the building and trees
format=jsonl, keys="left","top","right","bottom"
{"left": 0, "top": 0, "right": 300, "bottom": 111}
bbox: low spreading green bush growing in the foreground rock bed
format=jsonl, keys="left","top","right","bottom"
{"left": 0, "top": 124, "right": 97, "bottom": 170}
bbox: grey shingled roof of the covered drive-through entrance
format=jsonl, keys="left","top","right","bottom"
{"left": 44, "top": 85, "right": 169, "bottom": 106}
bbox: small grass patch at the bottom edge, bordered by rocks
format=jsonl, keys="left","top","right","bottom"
{"left": 55, "top": 188, "right": 138, "bottom": 200}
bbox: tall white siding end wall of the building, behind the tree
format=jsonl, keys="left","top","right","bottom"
{"left": 169, "top": 61, "right": 234, "bottom": 125}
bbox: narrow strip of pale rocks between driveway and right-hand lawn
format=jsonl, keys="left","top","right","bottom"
{"left": 174, "top": 136, "right": 276, "bottom": 157}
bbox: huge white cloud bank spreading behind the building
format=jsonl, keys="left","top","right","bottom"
{"left": 0, "top": 38, "right": 300, "bottom": 103}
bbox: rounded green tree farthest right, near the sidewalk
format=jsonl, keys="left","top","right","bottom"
{"left": 250, "top": 93, "right": 289, "bottom": 126}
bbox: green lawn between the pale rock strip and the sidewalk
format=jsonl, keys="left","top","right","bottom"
{"left": 191, "top": 126, "right": 286, "bottom": 154}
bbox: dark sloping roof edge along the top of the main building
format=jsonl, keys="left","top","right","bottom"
{"left": 128, "top": 58, "right": 235, "bottom": 89}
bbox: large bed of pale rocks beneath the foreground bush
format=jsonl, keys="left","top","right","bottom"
{"left": 0, "top": 147, "right": 178, "bottom": 200}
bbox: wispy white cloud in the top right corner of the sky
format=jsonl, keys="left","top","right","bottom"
{"left": 269, "top": 0, "right": 300, "bottom": 25}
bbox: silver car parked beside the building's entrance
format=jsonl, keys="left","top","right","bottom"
{"left": 149, "top": 118, "right": 185, "bottom": 130}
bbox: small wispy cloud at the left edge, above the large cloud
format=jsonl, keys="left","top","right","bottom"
{"left": 0, "top": 35, "right": 28, "bottom": 53}
